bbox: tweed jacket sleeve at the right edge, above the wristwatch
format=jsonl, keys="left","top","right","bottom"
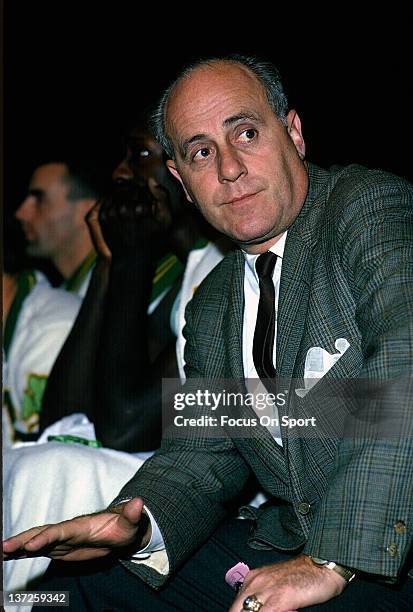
{"left": 304, "top": 170, "right": 413, "bottom": 581}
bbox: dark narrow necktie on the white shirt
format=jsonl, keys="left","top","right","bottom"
{"left": 252, "top": 251, "right": 277, "bottom": 379}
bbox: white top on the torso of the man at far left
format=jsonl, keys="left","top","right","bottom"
{"left": 3, "top": 272, "right": 81, "bottom": 432}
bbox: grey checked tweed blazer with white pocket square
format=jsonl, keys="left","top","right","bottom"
{"left": 117, "top": 164, "right": 413, "bottom": 586}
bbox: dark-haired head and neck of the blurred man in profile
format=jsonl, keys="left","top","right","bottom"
{"left": 15, "top": 159, "right": 104, "bottom": 297}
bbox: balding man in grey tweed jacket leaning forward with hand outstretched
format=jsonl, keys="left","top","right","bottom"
{"left": 5, "top": 58, "right": 413, "bottom": 611}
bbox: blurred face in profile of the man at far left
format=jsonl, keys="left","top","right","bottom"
{"left": 16, "top": 163, "right": 84, "bottom": 260}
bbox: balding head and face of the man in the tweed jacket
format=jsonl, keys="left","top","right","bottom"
{"left": 166, "top": 62, "right": 308, "bottom": 253}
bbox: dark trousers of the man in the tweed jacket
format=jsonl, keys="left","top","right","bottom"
{"left": 39, "top": 519, "right": 413, "bottom": 612}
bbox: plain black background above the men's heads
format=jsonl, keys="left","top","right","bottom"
{"left": 4, "top": 0, "right": 413, "bottom": 215}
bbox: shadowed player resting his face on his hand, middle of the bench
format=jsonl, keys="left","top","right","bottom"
{"left": 41, "top": 116, "right": 228, "bottom": 452}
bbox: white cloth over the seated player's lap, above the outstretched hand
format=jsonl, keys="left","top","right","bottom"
{"left": 3, "top": 414, "right": 148, "bottom": 612}
